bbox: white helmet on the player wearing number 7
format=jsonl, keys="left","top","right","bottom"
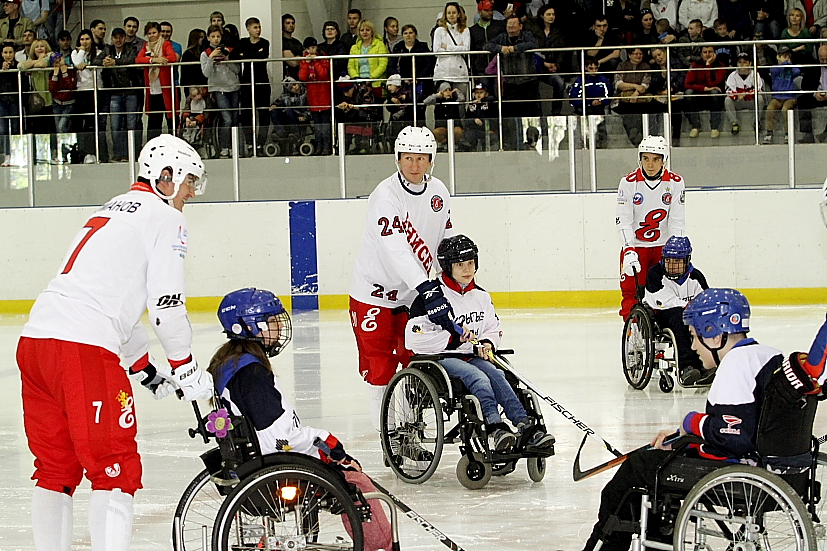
{"left": 138, "top": 134, "right": 207, "bottom": 200}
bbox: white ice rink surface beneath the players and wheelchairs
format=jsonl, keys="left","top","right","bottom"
{"left": 0, "top": 306, "right": 827, "bottom": 551}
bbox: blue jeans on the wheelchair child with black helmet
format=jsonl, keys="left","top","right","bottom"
{"left": 439, "top": 357, "right": 528, "bottom": 425}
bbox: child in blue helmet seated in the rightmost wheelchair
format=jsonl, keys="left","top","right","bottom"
{"left": 583, "top": 289, "right": 814, "bottom": 551}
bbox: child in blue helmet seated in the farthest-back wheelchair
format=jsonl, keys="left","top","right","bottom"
{"left": 643, "top": 235, "right": 715, "bottom": 386}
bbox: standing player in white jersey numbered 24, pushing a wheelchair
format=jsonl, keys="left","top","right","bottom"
{"left": 350, "top": 126, "right": 455, "bottom": 430}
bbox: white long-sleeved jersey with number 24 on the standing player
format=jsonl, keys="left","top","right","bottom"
{"left": 350, "top": 172, "right": 452, "bottom": 308}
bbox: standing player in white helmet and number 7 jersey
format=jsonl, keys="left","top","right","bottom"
{"left": 17, "top": 135, "right": 212, "bottom": 551}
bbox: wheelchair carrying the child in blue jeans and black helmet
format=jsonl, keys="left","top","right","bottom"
{"left": 380, "top": 350, "right": 554, "bottom": 490}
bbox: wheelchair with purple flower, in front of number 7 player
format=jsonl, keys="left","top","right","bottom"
{"left": 172, "top": 409, "right": 398, "bottom": 551}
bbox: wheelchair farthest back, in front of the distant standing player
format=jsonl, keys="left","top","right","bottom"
{"left": 620, "top": 289, "right": 712, "bottom": 392}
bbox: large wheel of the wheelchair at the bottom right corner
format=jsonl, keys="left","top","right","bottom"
{"left": 674, "top": 465, "right": 816, "bottom": 551}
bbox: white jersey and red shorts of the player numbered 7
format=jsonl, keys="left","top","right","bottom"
{"left": 17, "top": 183, "right": 192, "bottom": 495}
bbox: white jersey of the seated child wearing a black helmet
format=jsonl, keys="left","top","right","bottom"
{"left": 405, "top": 274, "right": 502, "bottom": 354}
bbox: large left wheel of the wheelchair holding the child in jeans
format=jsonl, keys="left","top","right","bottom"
{"left": 381, "top": 368, "right": 445, "bottom": 484}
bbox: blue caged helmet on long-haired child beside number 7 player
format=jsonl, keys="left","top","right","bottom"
{"left": 218, "top": 287, "right": 293, "bottom": 358}
